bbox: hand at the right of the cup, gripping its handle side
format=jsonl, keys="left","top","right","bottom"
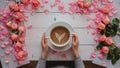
{"left": 72, "top": 34, "right": 79, "bottom": 58}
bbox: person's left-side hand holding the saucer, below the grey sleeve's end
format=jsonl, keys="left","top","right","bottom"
{"left": 41, "top": 33, "right": 49, "bottom": 59}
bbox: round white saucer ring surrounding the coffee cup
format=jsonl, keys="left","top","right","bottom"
{"left": 46, "top": 22, "right": 74, "bottom": 51}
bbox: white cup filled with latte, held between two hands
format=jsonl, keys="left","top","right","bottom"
{"left": 50, "top": 25, "right": 70, "bottom": 47}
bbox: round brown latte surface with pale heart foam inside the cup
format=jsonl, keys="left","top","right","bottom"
{"left": 50, "top": 26, "right": 70, "bottom": 45}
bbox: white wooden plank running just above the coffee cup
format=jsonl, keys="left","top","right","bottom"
{"left": 25, "top": 13, "right": 90, "bottom": 28}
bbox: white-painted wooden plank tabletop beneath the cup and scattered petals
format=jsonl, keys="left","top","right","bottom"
{"left": 0, "top": 0, "right": 120, "bottom": 68}
